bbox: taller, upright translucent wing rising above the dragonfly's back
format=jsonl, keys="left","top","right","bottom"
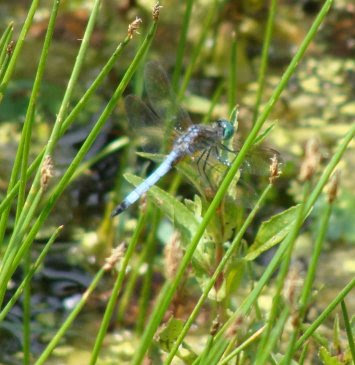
{"left": 144, "top": 61, "right": 192, "bottom": 135}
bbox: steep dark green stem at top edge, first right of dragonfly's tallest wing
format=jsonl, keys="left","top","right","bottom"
{"left": 172, "top": 0, "right": 194, "bottom": 92}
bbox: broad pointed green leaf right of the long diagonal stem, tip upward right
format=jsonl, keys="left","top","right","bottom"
{"left": 245, "top": 205, "right": 299, "bottom": 261}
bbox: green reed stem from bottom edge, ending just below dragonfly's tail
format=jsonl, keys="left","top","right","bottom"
{"left": 89, "top": 209, "right": 147, "bottom": 365}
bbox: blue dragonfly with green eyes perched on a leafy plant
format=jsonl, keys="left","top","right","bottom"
{"left": 112, "top": 61, "right": 276, "bottom": 216}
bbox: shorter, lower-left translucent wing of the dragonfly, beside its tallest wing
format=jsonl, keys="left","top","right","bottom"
{"left": 125, "top": 95, "right": 168, "bottom": 152}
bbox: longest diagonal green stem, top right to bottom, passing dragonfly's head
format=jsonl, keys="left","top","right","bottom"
{"left": 133, "top": 0, "right": 336, "bottom": 364}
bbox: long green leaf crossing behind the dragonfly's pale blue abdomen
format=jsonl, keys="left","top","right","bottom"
{"left": 124, "top": 174, "right": 199, "bottom": 243}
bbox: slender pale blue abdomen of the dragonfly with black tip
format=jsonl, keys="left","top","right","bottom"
{"left": 112, "top": 151, "right": 180, "bottom": 217}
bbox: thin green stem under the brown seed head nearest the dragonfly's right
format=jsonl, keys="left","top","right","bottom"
{"left": 164, "top": 184, "right": 272, "bottom": 365}
